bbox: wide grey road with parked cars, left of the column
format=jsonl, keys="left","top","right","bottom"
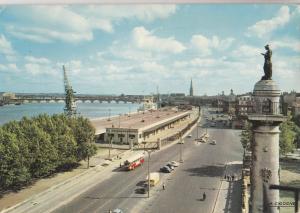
{"left": 55, "top": 109, "right": 242, "bottom": 213}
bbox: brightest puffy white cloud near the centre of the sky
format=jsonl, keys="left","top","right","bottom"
{"left": 133, "top": 27, "right": 186, "bottom": 53}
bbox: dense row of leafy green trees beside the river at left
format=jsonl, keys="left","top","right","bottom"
{"left": 0, "top": 114, "right": 96, "bottom": 190}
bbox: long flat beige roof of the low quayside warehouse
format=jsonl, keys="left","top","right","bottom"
{"left": 91, "top": 108, "right": 190, "bottom": 134}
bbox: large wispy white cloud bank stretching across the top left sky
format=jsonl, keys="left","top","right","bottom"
{"left": 5, "top": 5, "right": 176, "bottom": 43}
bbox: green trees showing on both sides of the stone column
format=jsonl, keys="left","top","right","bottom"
{"left": 241, "top": 113, "right": 300, "bottom": 155}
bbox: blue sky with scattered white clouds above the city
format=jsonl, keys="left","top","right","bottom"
{"left": 0, "top": 4, "right": 300, "bottom": 95}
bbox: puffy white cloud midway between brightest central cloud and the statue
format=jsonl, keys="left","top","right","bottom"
{"left": 191, "top": 34, "right": 234, "bottom": 55}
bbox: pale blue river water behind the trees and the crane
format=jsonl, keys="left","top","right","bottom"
{"left": 0, "top": 103, "right": 140, "bottom": 125}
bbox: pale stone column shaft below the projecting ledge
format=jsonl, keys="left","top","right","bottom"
{"left": 251, "top": 120, "right": 280, "bottom": 213}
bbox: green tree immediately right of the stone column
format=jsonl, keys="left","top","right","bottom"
{"left": 279, "top": 113, "right": 296, "bottom": 155}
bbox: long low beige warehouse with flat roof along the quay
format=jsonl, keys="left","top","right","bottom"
{"left": 91, "top": 108, "right": 192, "bottom": 146}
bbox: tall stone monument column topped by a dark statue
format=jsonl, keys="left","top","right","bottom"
{"left": 248, "top": 46, "right": 285, "bottom": 213}
